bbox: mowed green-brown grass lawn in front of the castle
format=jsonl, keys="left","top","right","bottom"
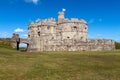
{"left": 0, "top": 48, "right": 120, "bottom": 80}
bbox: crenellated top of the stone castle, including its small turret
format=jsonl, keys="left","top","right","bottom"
{"left": 29, "top": 12, "right": 87, "bottom": 27}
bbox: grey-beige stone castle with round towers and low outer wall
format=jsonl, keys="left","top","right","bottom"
{"left": 11, "top": 11, "right": 115, "bottom": 52}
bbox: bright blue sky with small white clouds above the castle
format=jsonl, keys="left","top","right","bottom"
{"left": 0, "top": 0, "right": 120, "bottom": 41}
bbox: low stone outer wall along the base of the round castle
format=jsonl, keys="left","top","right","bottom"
{"left": 28, "top": 39, "right": 115, "bottom": 52}
